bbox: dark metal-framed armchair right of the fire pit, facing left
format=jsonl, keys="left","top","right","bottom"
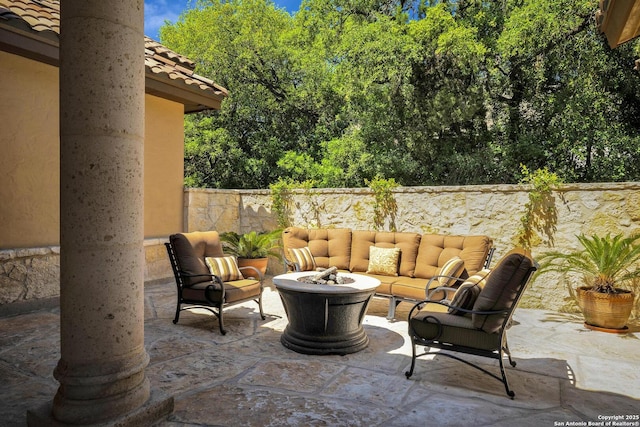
{"left": 405, "top": 249, "right": 537, "bottom": 399}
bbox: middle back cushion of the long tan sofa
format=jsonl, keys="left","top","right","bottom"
{"left": 349, "top": 230, "right": 420, "bottom": 277}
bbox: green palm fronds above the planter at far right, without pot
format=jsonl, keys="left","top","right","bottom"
{"left": 539, "top": 234, "right": 640, "bottom": 293}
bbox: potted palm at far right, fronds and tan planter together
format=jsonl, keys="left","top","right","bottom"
{"left": 539, "top": 234, "right": 640, "bottom": 332}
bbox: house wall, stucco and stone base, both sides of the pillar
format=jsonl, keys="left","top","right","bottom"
{"left": 0, "top": 51, "right": 184, "bottom": 306}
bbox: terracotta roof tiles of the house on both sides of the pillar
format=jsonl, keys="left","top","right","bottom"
{"left": 0, "top": 0, "right": 227, "bottom": 106}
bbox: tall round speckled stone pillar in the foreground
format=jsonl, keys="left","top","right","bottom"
{"left": 27, "top": 0, "right": 171, "bottom": 425}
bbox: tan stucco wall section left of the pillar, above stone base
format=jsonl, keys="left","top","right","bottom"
{"left": 0, "top": 51, "right": 60, "bottom": 249}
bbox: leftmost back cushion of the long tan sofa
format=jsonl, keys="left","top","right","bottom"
{"left": 282, "top": 227, "right": 351, "bottom": 270}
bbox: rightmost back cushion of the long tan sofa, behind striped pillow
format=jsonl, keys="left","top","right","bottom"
{"left": 414, "top": 234, "right": 493, "bottom": 279}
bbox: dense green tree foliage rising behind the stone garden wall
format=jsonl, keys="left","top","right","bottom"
{"left": 161, "top": 0, "right": 640, "bottom": 188}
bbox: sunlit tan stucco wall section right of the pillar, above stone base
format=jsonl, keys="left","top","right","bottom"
{"left": 144, "top": 95, "right": 184, "bottom": 238}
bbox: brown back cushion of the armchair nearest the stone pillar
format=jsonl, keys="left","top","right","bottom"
{"left": 169, "top": 231, "right": 224, "bottom": 286}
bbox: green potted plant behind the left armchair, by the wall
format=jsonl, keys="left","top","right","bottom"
{"left": 220, "top": 230, "right": 282, "bottom": 275}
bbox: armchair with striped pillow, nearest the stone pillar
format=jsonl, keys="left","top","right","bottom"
{"left": 165, "top": 231, "right": 265, "bottom": 335}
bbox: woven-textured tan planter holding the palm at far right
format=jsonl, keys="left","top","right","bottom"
{"left": 577, "top": 286, "right": 635, "bottom": 332}
